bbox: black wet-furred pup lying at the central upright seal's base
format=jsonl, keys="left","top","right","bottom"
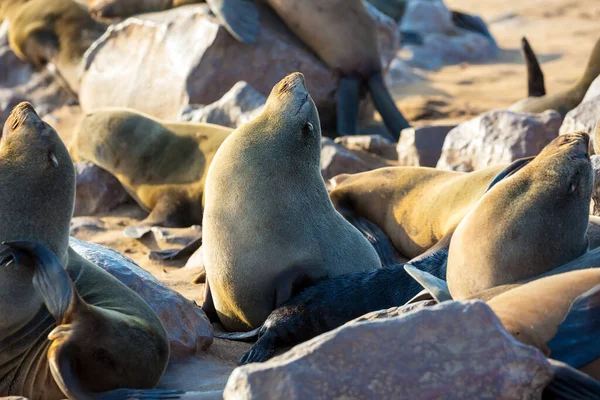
{"left": 240, "top": 250, "right": 448, "bottom": 364}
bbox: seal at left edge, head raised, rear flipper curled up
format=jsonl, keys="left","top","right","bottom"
{"left": 0, "top": 103, "right": 169, "bottom": 399}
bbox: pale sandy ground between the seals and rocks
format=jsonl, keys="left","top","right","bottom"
{"left": 43, "top": 0, "right": 600, "bottom": 389}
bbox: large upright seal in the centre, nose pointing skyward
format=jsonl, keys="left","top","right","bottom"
{"left": 202, "top": 73, "right": 381, "bottom": 331}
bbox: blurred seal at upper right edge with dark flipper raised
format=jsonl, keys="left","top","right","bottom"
{"left": 508, "top": 39, "right": 600, "bottom": 118}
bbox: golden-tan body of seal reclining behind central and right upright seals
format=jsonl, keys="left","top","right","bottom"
{"left": 330, "top": 165, "right": 505, "bottom": 259}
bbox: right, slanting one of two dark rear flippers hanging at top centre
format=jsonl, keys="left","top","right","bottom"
{"left": 367, "top": 72, "right": 410, "bottom": 141}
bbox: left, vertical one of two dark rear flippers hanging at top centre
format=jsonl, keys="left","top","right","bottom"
{"left": 337, "top": 76, "right": 361, "bottom": 135}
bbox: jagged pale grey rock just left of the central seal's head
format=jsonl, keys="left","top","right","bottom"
{"left": 179, "top": 82, "right": 267, "bottom": 128}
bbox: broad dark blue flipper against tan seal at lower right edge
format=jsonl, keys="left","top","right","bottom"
{"left": 548, "top": 285, "right": 600, "bottom": 368}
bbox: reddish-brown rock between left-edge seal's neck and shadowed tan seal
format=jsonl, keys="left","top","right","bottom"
{"left": 73, "top": 161, "right": 132, "bottom": 217}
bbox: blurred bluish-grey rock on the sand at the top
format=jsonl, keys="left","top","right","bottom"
{"left": 400, "top": 0, "right": 498, "bottom": 70}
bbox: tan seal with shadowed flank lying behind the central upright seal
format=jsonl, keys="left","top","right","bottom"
{"left": 70, "top": 108, "right": 233, "bottom": 238}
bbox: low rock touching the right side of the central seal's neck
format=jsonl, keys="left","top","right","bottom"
{"left": 321, "top": 138, "right": 390, "bottom": 182}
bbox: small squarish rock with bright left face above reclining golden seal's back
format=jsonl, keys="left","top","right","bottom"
{"left": 396, "top": 125, "right": 455, "bottom": 167}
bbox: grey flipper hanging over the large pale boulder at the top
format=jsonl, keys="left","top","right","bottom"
{"left": 206, "top": 0, "right": 260, "bottom": 44}
